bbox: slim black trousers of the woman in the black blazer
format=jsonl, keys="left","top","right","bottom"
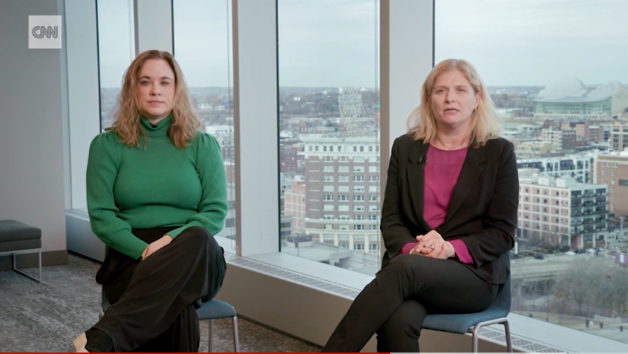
{"left": 323, "top": 254, "right": 499, "bottom": 352}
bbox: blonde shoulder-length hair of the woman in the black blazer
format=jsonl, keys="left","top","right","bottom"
{"left": 406, "top": 59, "right": 501, "bottom": 147}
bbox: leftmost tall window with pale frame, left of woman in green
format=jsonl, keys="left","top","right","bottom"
{"left": 65, "top": 0, "right": 134, "bottom": 212}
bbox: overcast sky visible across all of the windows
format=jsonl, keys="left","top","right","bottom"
{"left": 98, "top": 0, "right": 628, "bottom": 87}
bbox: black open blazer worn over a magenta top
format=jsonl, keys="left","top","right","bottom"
{"left": 381, "top": 135, "right": 519, "bottom": 284}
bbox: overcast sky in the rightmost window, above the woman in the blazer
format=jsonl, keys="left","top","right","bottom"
{"left": 435, "top": 0, "right": 628, "bottom": 85}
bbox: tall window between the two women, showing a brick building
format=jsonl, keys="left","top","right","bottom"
{"left": 278, "top": 0, "right": 381, "bottom": 274}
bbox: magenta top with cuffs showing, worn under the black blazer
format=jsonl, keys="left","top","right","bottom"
{"left": 399, "top": 145, "right": 473, "bottom": 263}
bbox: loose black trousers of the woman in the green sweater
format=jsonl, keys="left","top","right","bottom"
{"left": 93, "top": 226, "right": 226, "bottom": 352}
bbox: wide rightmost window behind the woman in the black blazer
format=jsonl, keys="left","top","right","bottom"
{"left": 435, "top": 0, "right": 628, "bottom": 343}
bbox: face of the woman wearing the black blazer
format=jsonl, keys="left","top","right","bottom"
{"left": 430, "top": 70, "right": 481, "bottom": 130}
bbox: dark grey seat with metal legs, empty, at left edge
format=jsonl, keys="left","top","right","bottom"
{"left": 0, "top": 220, "right": 41, "bottom": 283}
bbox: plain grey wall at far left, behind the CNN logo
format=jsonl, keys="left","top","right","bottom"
{"left": 0, "top": 0, "right": 67, "bottom": 264}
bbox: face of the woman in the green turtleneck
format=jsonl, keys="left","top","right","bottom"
{"left": 137, "top": 59, "right": 175, "bottom": 124}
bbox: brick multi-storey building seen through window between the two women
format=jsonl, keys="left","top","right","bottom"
{"left": 298, "top": 134, "right": 380, "bottom": 254}
